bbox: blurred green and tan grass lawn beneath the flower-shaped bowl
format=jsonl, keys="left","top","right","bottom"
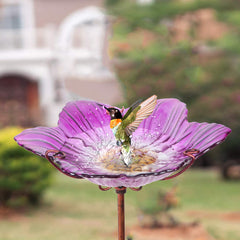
{"left": 0, "top": 170, "right": 240, "bottom": 240}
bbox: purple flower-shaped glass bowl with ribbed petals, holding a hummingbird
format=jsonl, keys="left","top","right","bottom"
{"left": 15, "top": 99, "right": 231, "bottom": 187}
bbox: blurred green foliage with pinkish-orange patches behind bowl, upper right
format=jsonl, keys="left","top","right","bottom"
{"left": 107, "top": 0, "right": 240, "bottom": 164}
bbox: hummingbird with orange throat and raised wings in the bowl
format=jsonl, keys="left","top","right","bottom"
{"left": 104, "top": 95, "right": 157, "bottom": 166}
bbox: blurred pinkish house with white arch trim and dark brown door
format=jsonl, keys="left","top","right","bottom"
{"left": 0, "top": 0, "right": 122, "bottom": 127}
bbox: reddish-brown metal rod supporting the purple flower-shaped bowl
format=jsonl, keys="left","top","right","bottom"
{"left": 115, "top": 187, "right": 126, "bottom": 240}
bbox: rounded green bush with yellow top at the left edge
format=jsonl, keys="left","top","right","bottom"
{"left": 0, "top": 127, "right": 52, "bottom": 206}
